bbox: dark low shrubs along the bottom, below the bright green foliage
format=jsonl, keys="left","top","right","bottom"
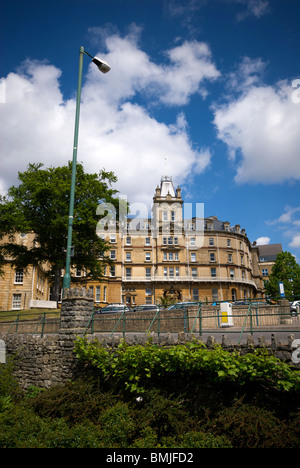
{"left": 0, "top": 374, "right": 300, "bottom": 449}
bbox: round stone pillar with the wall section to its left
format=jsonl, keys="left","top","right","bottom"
{"left": 0, "top": 288, "right": 93, "bottom": 388}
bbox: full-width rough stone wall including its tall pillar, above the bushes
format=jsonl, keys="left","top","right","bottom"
{"left": 0, "top": 288, "right": 300, "bottom": 388}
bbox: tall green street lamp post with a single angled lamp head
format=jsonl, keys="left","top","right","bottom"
{"left": 63, "top": 46, "right": 110, "bottom": 290}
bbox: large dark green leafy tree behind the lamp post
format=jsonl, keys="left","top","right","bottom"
{"left": 0, "top": 163, "right": 119, "bottom": 300}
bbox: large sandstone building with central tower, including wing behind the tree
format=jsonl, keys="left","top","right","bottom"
{"left": 0, "top": 176, "right": 263, "bottom": 310}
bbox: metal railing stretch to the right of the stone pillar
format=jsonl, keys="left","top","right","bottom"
{"left": 83, "top": 300, "right": 300, "bottom": 343}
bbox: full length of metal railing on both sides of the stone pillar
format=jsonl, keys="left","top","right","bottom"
{"left": 0, "top": 299, "right": 300, "bottom": 343}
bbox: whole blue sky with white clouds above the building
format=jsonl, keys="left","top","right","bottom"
{"left": 0, "top": 0, "right": 300, "bottom": 262}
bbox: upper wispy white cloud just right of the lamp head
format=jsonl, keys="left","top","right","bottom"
{"left": 90, "top": 34, "right": 220, "bottom": 106}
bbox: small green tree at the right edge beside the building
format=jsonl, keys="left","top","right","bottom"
{"left": 265, "top": 252, "right": 300, "bottom": 297}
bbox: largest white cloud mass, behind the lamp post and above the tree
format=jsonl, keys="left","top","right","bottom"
{"left": 0, "top": 30, "right": 219, "bottom": 209}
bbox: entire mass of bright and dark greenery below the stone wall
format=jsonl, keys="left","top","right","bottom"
{"left": 0, "top": 340, "right": 300, "bottom": 449}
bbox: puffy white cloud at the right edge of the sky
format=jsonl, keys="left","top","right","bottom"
{"left": 214, "top": 74, "right": 300, "bottom": 184}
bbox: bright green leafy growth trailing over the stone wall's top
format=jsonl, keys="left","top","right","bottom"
{"left": 75, "top": 338, "right": 300, "bottom": 393}
